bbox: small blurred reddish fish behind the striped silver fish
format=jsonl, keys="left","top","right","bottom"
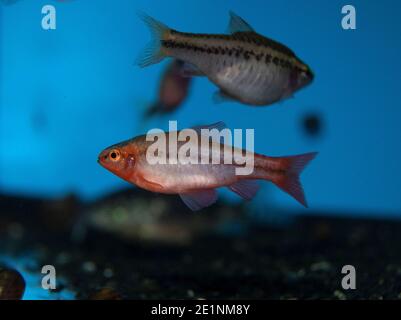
{"left": 144, "top": 60, "right": 192, "bottom": 119}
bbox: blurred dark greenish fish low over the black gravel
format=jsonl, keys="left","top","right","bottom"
{"left": 74, "top": 189, "right": 243, "bottom": 245}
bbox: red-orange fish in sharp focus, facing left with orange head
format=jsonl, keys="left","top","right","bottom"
{"left": 98, "top": 123, "right": 316, "bottom": 211}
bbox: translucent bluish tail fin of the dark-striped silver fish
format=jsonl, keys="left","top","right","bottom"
{"left": 136, "top": 12, "right": 170, "bottom": 68}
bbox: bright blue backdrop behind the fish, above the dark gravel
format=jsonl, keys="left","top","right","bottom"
{"left": 0, "top": 0, "right": 401, "bottom": 216}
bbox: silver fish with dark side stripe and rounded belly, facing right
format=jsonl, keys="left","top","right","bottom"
{"left": 138, "top": 12, "right": 314, "bottom": 106}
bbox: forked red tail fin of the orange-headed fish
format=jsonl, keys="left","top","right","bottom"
{"left": 272, "top": 152, "right": 317, "bottom": 208}
